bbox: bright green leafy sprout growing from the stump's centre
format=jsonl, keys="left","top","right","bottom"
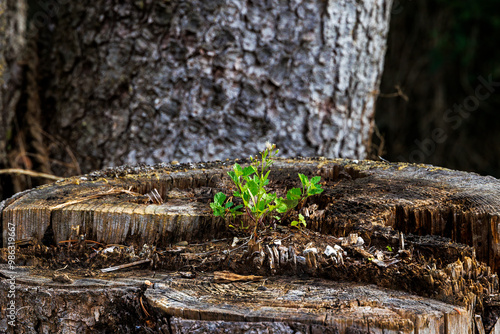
{"left": 210, "top": 143, "right": 323, "bottom": 235}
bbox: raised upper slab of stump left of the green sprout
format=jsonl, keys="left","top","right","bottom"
{"left": 0, "top": 163, "right": 226, "bottom": 246}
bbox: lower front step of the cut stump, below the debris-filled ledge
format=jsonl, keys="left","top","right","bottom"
{"left": 0, "top": 265, "right": 474, "bottom": 334}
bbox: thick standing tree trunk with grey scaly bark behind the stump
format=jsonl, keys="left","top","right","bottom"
{"left": 40, "top": 0, "right": 391, "bottom": 175}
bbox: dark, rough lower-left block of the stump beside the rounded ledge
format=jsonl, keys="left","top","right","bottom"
{"left": 0, "top": 264, "right": 147, "bottom": 334}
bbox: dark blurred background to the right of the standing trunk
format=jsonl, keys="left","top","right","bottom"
{"left": 372, "top": 0, "right": 500, "bottom": 178}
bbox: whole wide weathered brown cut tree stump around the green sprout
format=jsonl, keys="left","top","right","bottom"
{"left": 0, "top": 158, "right": 500, "bottom": 333}
